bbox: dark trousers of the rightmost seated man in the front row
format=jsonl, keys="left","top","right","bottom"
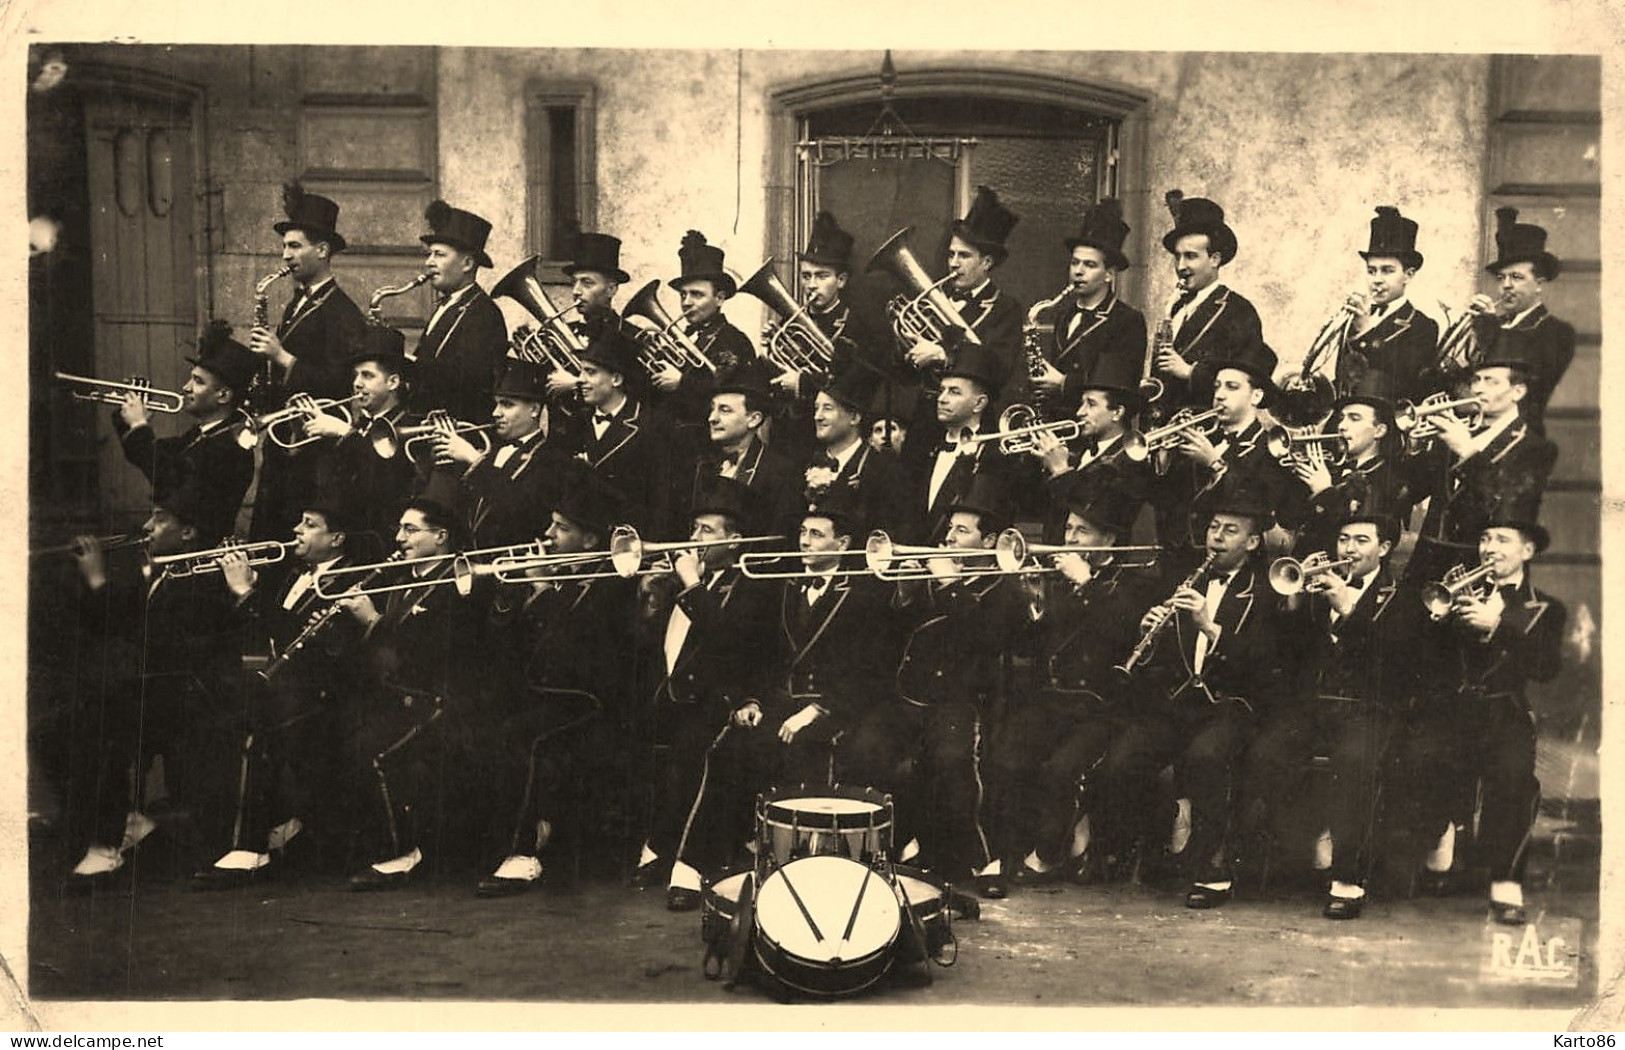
{"left": 1391, "top": 694, "right": 1541, "bottom": 881}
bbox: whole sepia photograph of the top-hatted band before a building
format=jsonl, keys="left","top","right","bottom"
{"left": 15, "top": 11, "right": 1615, "bottom": 1024}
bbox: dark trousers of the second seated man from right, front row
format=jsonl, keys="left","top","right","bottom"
{"left": 1243, "top": 697, "right": 1391, "bottom": 884}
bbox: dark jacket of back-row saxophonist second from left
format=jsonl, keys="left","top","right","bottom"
{"left": 411, "top": 284, "right": 509, "bottom": 423}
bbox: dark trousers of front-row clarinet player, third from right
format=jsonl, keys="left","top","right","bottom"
{"left": 1090, "top": 699, "right": 1253, "bottom": 881}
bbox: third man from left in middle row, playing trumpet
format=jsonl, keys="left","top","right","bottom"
{"left": 427, "top": 359, "right": 570, "bottom": 548}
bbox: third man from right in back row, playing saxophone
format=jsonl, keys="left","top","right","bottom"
{"left": 1154, "top": 190, "right": 1264, "bottom": 408}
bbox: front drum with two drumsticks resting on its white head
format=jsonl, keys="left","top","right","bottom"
{"left": 754, "top": 857, "right": 902, "bottom": 996}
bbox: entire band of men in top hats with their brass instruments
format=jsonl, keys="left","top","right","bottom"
{"left": 44, "top": 177, "right": 1575, "bottom": 923}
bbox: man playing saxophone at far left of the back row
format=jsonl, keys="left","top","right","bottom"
{"left": 249, "top": 182, "right": 367, "bottom": 540}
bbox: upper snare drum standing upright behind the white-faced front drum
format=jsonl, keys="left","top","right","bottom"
{"left": 756, "top": 785, "right": 892, "bottom": 873}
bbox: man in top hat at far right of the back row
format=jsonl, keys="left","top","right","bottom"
{"left": 1445, "top": 208, "right": 1575, "bottom": 436}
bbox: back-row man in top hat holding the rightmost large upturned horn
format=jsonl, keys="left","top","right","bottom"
{"left": 904, "top": 185, "right": 1025, "bottom": 431}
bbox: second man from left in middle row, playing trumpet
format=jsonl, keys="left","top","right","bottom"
{"left": 304, "top": 325, "right": 421, "bottom": 543}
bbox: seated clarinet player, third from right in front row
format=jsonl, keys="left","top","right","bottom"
{"left": 1092, "top": 484, "right": 1282, "bottom": 909}
